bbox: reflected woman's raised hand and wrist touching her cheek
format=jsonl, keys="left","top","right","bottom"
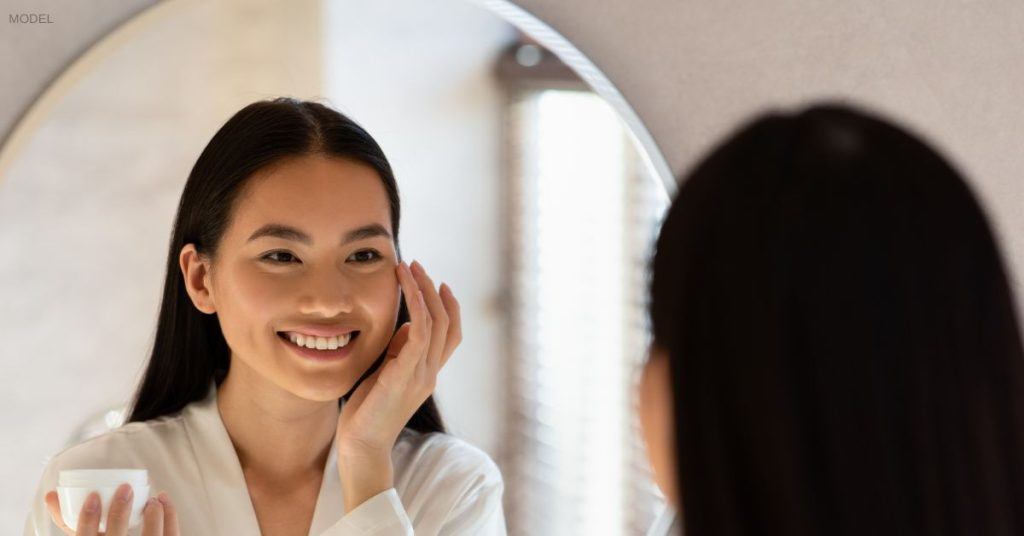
{"left": 335, "top": 261, "right": 462, "bottom": 511}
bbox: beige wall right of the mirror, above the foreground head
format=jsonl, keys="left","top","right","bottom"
{"left": 516, "top": 0, "right": 1024, "bottom": 311}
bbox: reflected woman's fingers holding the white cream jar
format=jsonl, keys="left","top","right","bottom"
{"left": 46, "top": 484, "right": 180, "bottom": 536}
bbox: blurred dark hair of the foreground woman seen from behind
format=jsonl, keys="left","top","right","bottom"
{"left": 650, "top": 104, "right": 1024, "bottom": 536}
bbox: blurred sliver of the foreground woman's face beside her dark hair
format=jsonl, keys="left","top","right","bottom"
{"left": 639, "top": 344, "right": 679, "bottom": 508}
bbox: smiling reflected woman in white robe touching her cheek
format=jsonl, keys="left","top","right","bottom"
{"left": 26, "top": 98, "right": 505, "bottom": 536}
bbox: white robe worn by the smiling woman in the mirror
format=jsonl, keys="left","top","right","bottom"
{"left": 25, "top": 381, "right": 505, "bottom": 536}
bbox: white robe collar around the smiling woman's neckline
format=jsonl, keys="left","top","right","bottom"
{"left": 182, "top": 380, "right": 345, "bottom": 536}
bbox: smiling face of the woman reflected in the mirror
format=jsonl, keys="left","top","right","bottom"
{"left": 181, "top": 155, "right": 399, "bottom": 401}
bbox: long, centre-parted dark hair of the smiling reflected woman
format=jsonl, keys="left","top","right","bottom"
{"left": 128, "top": 97, "right": 444, "bottom": 432}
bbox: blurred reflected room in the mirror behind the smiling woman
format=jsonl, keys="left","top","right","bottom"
{"left": 0, "top": 0, "right": 668, "bottom": 535}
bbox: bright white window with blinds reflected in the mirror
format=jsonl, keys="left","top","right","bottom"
{"left": 503, "top": 85, "right": 666, "bottom": 535}
